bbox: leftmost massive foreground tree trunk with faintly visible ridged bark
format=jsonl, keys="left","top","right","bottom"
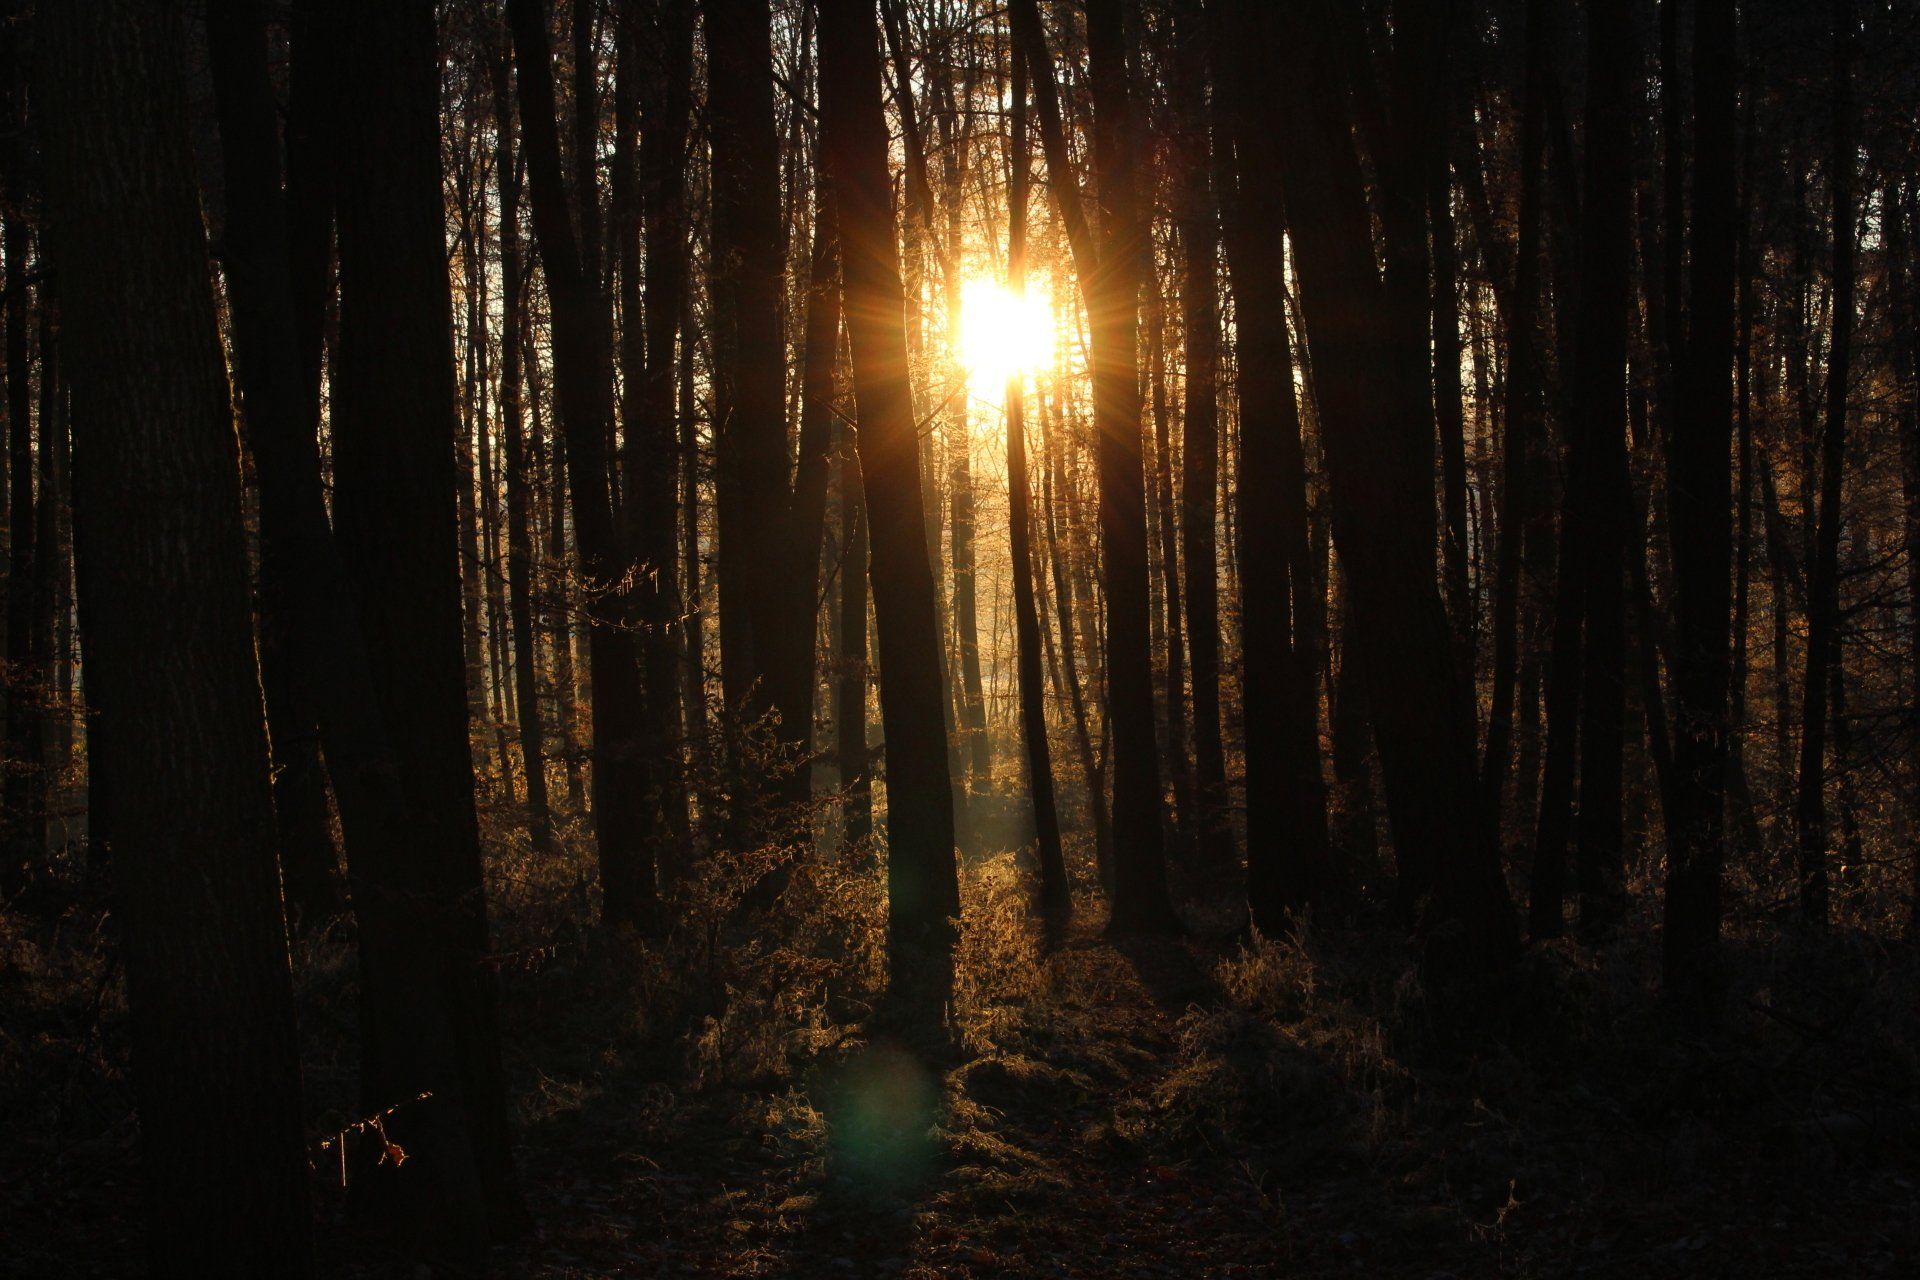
{"left": 37, "top": 0, "right": 313, "bottom": 1276}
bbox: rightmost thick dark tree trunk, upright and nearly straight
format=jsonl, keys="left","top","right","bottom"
{"left": 1663, "top": 0, "right": 1736, "bottom": 1000}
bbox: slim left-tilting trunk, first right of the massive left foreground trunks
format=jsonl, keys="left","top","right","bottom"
{"left": 507, "top": 0, "right": 659, "bottom": 931}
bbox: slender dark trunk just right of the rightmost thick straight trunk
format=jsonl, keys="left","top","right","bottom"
{"left": 1793, "top": 0, "right": 1855, "bottom": 925}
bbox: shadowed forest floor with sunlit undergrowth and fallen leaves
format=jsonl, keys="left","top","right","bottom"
{"left": 0, "top": 817, "right": 1920, "bottom": 1280}
